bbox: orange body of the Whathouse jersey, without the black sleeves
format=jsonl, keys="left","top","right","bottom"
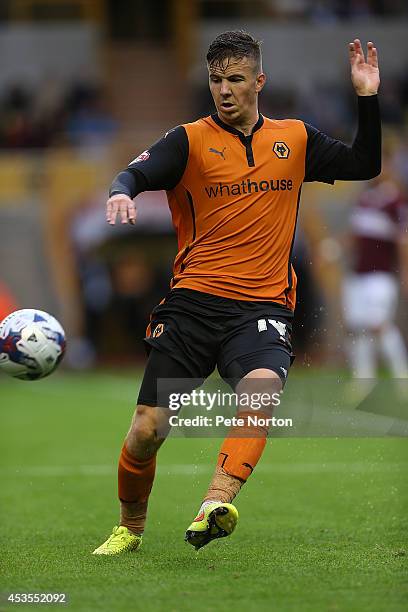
{"left": 167, "top": 117, "right": 307, "bottom": 309}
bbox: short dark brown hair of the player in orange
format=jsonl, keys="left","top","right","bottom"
{"left": 207, "top": 30, "right": 262, "bottom": 70}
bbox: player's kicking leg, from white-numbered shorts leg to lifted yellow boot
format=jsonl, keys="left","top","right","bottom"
{"left": 186, "top": 305, "right": 293, "bottom": 549}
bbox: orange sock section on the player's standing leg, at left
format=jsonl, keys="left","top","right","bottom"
{"left": 118, "top": 444, "right": 156, "bottom": 502}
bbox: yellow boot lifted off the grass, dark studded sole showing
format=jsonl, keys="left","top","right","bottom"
{"left": 184, "top": 502, "right": 239, "bottom": 550}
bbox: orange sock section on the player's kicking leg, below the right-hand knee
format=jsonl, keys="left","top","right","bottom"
{"left": 217, "top": 410, "right": 270, "bottom": 482}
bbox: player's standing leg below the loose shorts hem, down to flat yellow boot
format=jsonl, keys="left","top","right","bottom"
{"left": 94, "top": 349, "right": 194, "bottom": 555}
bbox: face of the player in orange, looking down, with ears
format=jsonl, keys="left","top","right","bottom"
{"left": 208, "top": 57, "right": 265, "bottom": 127}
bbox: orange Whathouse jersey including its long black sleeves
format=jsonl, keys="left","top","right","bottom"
{"left": 115, "top": 96, "right": 381, "bottom": 310}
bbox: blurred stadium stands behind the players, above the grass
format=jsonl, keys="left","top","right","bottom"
{"left": 0, "top": 0, "right": 408, "bottom": 368}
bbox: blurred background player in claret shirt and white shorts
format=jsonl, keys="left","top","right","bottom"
{"left": 343, "top": 160, "right": 408, "bottom": 384}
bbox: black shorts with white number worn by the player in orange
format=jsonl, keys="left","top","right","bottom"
{"left": 138, "top": 289, "right": 294, "bottom": 406}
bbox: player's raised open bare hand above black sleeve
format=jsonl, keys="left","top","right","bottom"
{"left": 349, "top": 38, "right": 380, "bottom": 96}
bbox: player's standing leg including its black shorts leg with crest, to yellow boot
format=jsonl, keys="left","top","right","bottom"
{"left": 95, "top": 289, "right": 223, "bottom": 554}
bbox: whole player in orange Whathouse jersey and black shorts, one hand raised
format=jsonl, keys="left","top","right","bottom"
{"left": 94, "top": 31, "right": 381, "bottom": 555}
